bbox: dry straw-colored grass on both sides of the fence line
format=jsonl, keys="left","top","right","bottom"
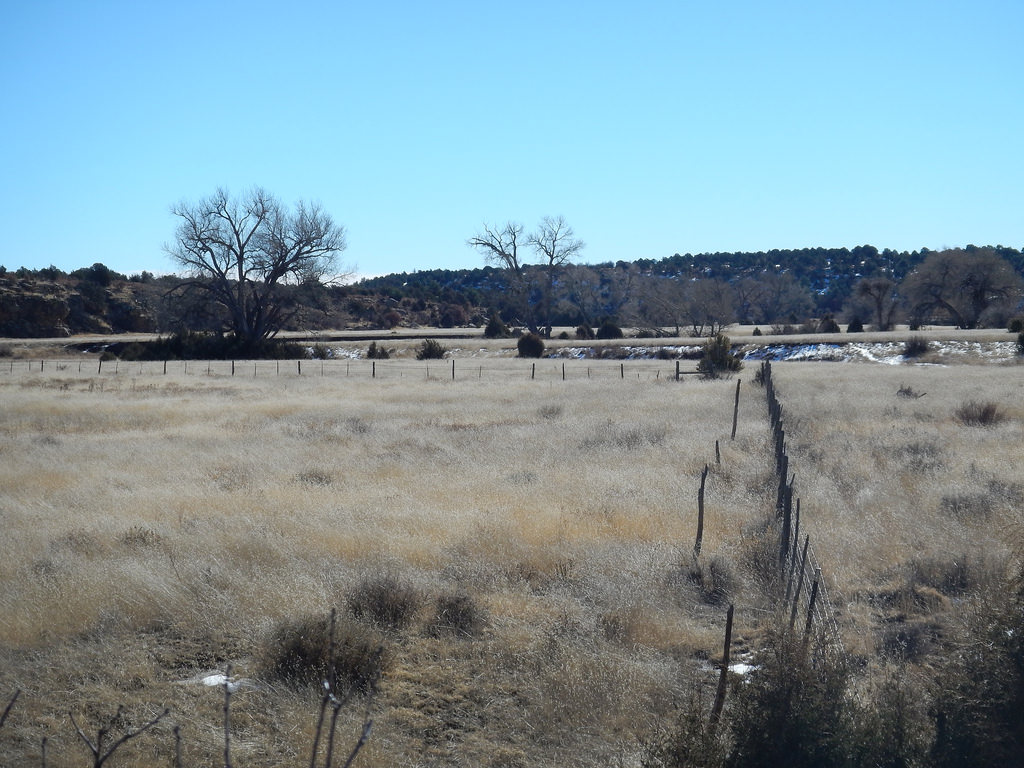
{"left": 0, "top": 359, "right": 1024, "bottom": 768}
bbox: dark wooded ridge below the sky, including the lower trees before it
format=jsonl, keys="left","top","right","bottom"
{"left": 0, "top": 245, "right": 1024, "bottom": 337}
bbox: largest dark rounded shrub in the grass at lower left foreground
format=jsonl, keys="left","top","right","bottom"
{"left": 258, "top": 616, "right": 386, "bottom": 693}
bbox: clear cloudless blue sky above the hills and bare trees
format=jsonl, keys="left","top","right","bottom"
{"left": 0, "top": 0, "right": 1024, "bottom": 274}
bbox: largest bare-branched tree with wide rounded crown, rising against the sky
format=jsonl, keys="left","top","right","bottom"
{"left": 165, "top": 187, "right": 345, "bottom": 350}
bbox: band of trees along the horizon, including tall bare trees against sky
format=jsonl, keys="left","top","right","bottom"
{"left": 0, "top": 187, "right": 1024, "bottom": 346}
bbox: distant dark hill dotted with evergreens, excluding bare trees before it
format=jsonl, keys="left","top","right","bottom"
{"left": 0, "top": 245, "right": 1024, "bottom": 337}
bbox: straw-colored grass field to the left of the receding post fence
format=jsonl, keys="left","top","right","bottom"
{"left": 0, "top": 360, "right": 771, "bottom": 766}
